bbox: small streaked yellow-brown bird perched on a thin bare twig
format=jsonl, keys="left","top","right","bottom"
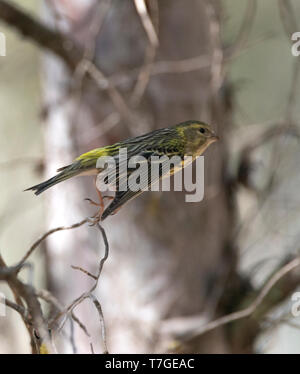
{"left": 25, "top": 121, "right": 219, "bottom": 221}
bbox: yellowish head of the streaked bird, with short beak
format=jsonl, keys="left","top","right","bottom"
{"left": 177, "top": 121, "right": 219, "bottom": 157}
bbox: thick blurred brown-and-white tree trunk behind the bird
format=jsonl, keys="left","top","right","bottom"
{"left": 45, "top": 0, "right": 236, "bottom": 353}
